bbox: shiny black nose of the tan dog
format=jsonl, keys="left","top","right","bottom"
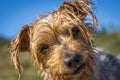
{"left": 64, "top": 54, "right": 82, "bottom": 68}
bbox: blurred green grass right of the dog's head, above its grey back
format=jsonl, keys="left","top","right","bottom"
{"left": 95, "top": 33, "right": 120, "bottom": 55}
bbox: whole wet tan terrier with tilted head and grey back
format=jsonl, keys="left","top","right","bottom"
{"left": 9, "top": 0, "right": 120, "bottom": 80}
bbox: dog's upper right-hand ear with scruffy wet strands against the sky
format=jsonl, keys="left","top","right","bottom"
{"left": 59, "top": 0, "right": 98, "bottom": 26}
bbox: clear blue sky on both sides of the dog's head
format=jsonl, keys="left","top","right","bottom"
{"left": 0, "top": 0, "right": 120, "bottom": 39}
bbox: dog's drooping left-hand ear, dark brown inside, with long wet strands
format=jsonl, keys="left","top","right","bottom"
{"left": 8, "top": 25, "right": 30, "bottom": 74}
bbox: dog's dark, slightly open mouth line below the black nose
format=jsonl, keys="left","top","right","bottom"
{"left": 65, "top": 63, "right": 86, "bottom": 76}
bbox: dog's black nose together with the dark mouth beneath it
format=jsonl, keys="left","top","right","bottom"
{"left": 64, "top": 54, "right": 86, "bottom": 75}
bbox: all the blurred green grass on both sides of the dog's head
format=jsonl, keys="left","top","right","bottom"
{"left": 0, "top": 33, "right": 120, "bottom": 80}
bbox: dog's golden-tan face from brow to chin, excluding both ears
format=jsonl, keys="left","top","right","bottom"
{"left": 30, "top": 15, "right": 91, "bottom": 75}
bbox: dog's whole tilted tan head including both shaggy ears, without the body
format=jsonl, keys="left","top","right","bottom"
{"left": 10, "top": 0, "right": 98, "bottom": 79}
